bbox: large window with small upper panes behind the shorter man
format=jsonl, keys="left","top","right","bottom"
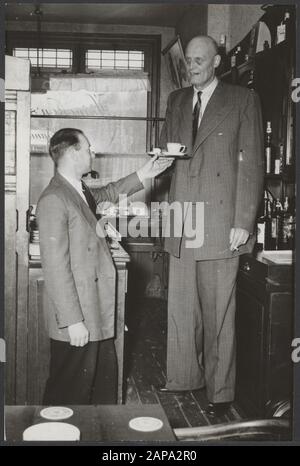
{"left": 6, "top": 31, "right": 161, "bottom": 204}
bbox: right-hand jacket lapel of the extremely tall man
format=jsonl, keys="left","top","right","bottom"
{"left": 193, "top": 82, "right": 232, "bottom": 153}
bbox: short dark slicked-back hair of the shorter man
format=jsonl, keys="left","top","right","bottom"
{"left": 49, "top": 128, "right": 84, "bottom": 164}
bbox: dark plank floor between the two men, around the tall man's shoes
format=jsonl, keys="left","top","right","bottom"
{"left": 125, "top": 298, "right": 245, "bottom": 428}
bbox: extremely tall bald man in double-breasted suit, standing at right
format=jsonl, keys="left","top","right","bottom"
{"left": 159, "top": 36, "right": 263, "bottom": 416}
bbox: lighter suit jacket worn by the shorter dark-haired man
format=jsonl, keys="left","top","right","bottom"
{"left": 37, "top": 173, "right": 143, "bottom": 341}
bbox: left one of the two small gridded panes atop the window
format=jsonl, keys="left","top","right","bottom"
{"left": 13, "top": 48, "right": 72, "bottom": 69}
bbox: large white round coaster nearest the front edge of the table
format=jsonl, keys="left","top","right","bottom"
{"left": 23, "top": 422, "right": 80, "bottom": 441}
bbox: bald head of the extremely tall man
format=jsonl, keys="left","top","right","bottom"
{"left": 185, "top": 38, "right": 220, "bottom": 89}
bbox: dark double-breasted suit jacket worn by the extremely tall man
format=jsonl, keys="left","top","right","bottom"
{"left": 160, "top": 82, "right": 263, "bottom": 260}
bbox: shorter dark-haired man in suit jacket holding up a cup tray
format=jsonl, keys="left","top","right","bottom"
{"left": 37, "top": 128, "right": 172, "bottom": 405}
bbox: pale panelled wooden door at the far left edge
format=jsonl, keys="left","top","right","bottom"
{"left": 5, "top": 57, "right": 30, "bottom": 404}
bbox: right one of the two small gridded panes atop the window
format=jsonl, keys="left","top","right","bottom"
{"left": 85, "top": 50, "right": 144, "bottom": 71}
